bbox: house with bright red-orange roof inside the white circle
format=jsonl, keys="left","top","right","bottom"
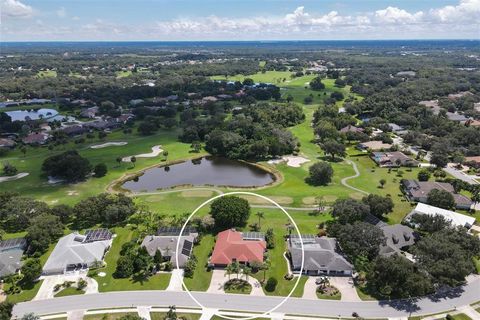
{"left": 209, "top": 229, "right": 267, "bottom": 267}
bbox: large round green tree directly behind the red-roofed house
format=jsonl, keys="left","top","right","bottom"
{"left": 210, "top": 196, "right": 250, "bottom": 229}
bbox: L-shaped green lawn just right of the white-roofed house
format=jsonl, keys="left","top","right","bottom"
{"left": 94, "top": 227, "right": 171, "bottom": 292}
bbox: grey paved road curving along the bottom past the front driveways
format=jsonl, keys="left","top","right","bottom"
{"left": 13, "top": 277, "right": 480, "bottom": 318}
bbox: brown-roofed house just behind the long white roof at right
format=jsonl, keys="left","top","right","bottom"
{"left": 401, "top": 180, "right": 472, "bottom": 210}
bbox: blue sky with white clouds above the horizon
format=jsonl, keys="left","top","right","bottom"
{"left": 0, "top": 0, "right": 480, "bottom": 41}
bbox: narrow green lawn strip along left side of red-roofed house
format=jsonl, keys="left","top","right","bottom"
{"left": 183, "top": 234, "right": 215, "bottom": 291}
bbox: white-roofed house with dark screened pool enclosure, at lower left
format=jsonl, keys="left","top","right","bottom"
{"left": 42, "top": 229, "right": 112, "bottom": 275}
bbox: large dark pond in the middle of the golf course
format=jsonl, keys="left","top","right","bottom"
{"left": 122, "top": 156, "right": 275, "bottom": 192}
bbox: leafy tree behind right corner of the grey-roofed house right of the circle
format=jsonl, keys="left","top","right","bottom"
{"left": 327, "top": 221, "right": 385, "bottom": 261}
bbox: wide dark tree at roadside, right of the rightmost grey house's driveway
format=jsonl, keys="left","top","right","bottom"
{"left": 367, "top": 254, "right": 433, "bottom": 298}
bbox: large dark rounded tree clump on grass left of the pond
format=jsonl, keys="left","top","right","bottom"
{"left": 42, "top": 150, "right": 92, "bottom": 182}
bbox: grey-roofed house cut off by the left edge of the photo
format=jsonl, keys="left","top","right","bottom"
{"left": 0, "top": 238, "right": 27, "bottom": 278}
